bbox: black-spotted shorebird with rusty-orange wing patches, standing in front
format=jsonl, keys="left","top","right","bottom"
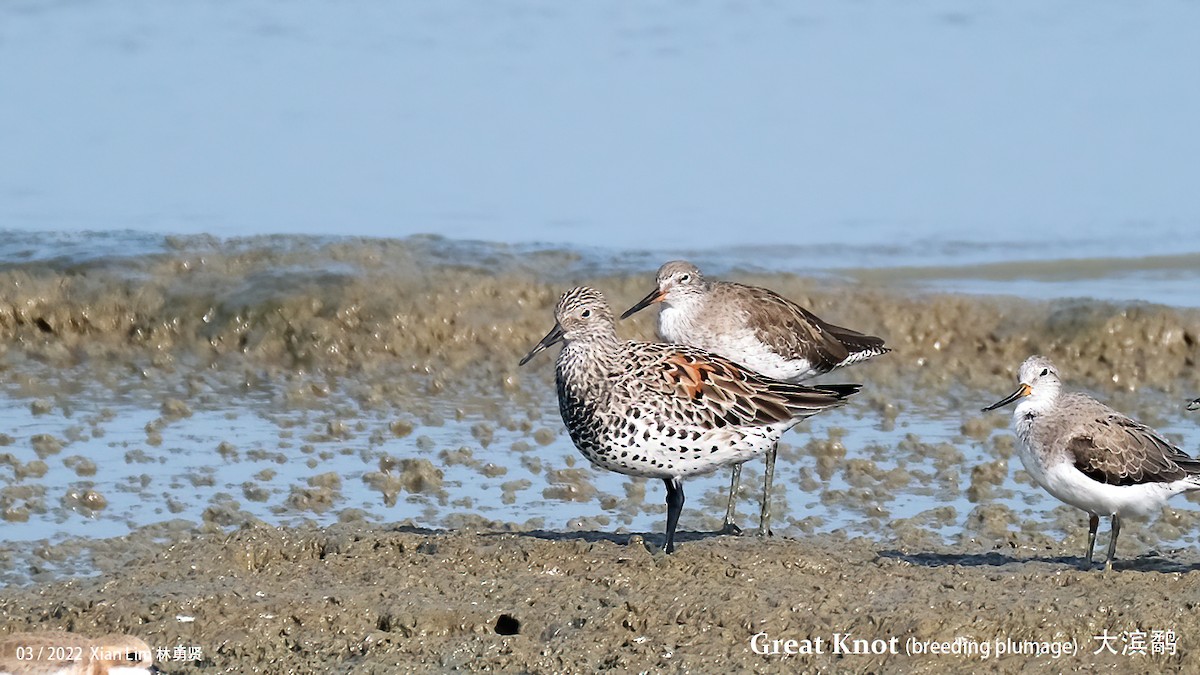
{"left": 521, "top": 287, "right": 860, "bottom": 552}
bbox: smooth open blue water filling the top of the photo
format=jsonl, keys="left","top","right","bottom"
{"left": 0, "top": 0, "right": 1200, "bottom": 257}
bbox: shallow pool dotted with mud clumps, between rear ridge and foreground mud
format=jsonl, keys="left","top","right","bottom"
{"left": 11, "top": 369, "right": 1200, "bottom": 569}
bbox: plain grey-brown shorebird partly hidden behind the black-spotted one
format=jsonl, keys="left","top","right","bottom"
{"left": 620, "top": 261, "right": 890, "bottom": 536}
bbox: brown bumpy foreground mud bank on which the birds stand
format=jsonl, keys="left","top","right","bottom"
{"left": 0, "top": 524, "right": 1200, "bottom": 673}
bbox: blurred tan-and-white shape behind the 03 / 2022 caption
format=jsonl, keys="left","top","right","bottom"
{"left": 0, "top": 631, "right": 161, "bottom": 675}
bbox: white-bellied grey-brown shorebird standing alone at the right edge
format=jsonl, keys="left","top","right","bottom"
{"left": 983, "top": 357, "right": 1200, "bottom": 569}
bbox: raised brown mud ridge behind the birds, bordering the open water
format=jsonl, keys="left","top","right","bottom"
{"left": 0, "top": 237, "right": 1200, "bottom": 398}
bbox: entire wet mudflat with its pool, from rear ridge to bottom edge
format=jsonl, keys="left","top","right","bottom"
{"left": 0, "top": 238, "right": 1200, "bottom": 673}
